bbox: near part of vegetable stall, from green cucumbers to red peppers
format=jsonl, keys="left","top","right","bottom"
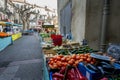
{"left": 44, "top": 43, "right": 120, "bottom": 80}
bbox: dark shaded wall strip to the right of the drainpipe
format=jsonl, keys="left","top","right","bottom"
{"left": 107, "top": 0, "right": 120, "bottom": 43}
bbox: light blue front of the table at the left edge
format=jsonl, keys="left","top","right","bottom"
{"left": 0, "top": 36, "right": 12, "bottom": 51}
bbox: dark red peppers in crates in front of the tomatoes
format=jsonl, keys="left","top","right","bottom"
{"left": 49, "top": 66, "right": 87, "bottom": 80}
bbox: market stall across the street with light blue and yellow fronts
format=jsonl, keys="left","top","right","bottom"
{"left": 0, "top": 21, "right": 22, "bottom": 51}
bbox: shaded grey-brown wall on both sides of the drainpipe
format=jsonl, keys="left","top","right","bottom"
{"left": 85, "top": 0, "right": 120, "bottom": 49}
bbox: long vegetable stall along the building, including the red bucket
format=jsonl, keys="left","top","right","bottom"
{"left": 40, "top": 24, "right": 120, "bottom": 80}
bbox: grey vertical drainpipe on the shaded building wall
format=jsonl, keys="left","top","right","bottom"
{"left": 100, "top": 0, "right": 110, "bottom": 52}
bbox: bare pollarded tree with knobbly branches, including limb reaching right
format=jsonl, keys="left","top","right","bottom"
{"left": 10, "top": 0, "right": 54, "bottom": 30}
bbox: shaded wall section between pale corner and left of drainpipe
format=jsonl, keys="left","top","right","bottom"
{"left": 85, "top": 0, "right": 103, "bottom": 49}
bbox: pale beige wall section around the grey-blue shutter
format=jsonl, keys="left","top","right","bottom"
{"left": 58, "top": 0, "right": 86, "bottom": 42}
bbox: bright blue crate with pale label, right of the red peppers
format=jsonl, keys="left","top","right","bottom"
{"left": 78, "top": 63, "right": 102, "bottom": 80}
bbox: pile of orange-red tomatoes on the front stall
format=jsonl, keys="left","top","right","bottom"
{"left": 48, "top": 53, "right": 96, "bottom": 69}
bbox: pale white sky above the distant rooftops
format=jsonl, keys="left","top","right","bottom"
{"left": 26, "top": 0, "right": 57, "bottom": 9}
